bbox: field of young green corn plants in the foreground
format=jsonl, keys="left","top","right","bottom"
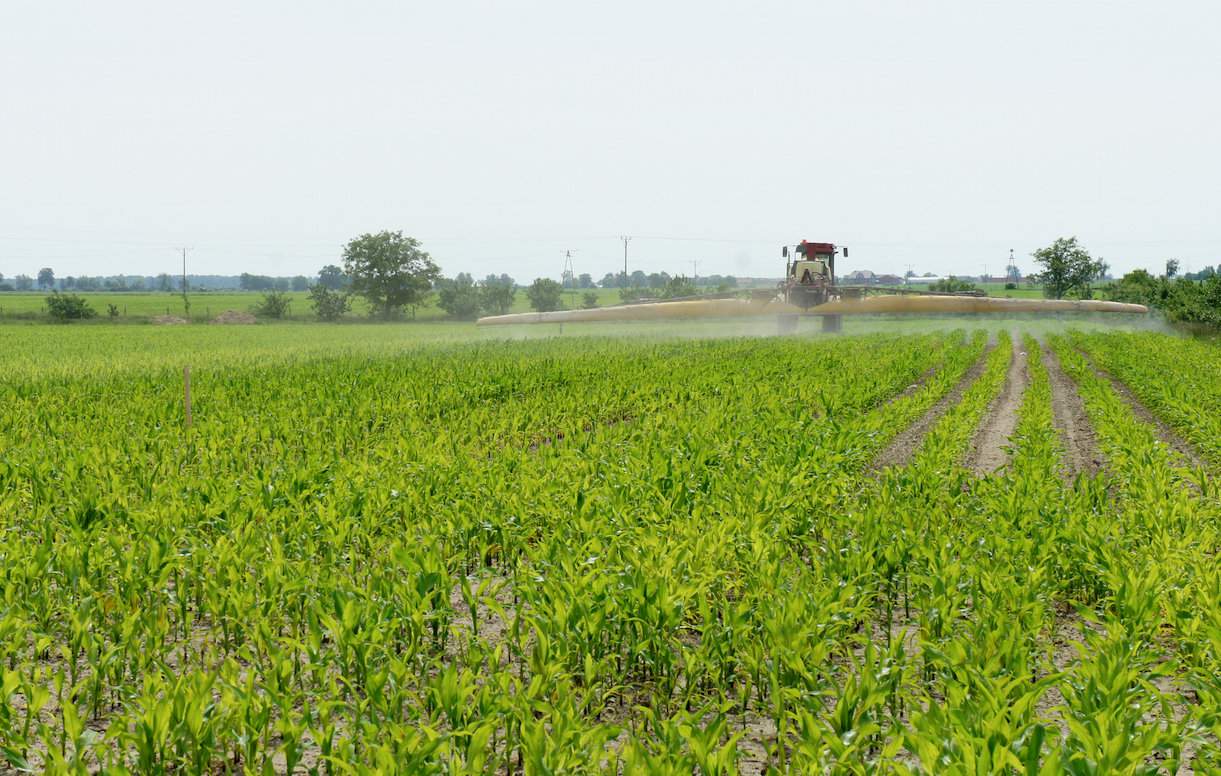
{"left": 0, "top": 327, "right": 1221, "bottom": 776}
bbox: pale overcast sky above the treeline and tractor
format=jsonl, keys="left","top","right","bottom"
{"left": 0, "top": 0, "right": 1221, "bottom": 281}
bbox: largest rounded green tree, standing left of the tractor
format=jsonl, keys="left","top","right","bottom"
{"left": 343, "top": 231, "right": 441, "bottom": 318}
